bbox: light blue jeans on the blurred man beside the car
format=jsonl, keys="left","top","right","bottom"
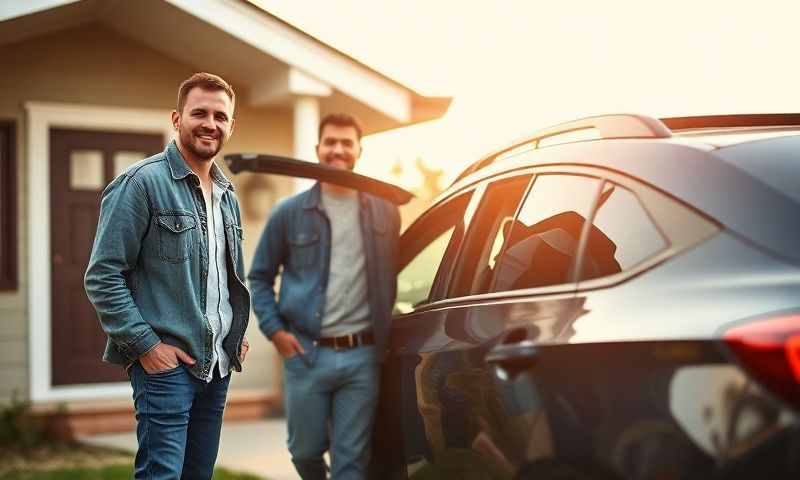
{"left": 283, "top": 347, "right": 380, "bottom": 480}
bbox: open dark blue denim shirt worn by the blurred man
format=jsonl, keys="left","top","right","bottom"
{"left": 247, "top": 183, "right": 400, "bottom": 364}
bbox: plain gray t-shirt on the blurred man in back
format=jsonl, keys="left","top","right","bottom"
{"left": 321, "top": 191, "right": 370, "bottom": 337}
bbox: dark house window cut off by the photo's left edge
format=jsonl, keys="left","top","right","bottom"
{"left": 0, "top": 122, "right": 17, "bottom": 290}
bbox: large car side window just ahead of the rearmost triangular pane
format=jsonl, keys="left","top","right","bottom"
{"left": 491, "top": 174, "right": 601, "bottom": 292}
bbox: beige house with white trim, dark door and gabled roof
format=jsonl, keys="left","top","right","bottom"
{"left": 0, "top": 0, "right": 449, "bottom": 433}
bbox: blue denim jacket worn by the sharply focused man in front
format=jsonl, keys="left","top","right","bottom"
{"left": 84, "top": 141, "right": 250, "bottom": 379}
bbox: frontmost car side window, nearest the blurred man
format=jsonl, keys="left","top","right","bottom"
{"left": 394, "top": 194, "right": 471, "bottom": 314}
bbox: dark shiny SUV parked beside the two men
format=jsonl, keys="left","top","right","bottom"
{"left": 373, "top": 114, "right": 800, "bottom": 479}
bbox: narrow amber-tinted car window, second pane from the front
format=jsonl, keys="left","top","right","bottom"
{"left": 449, "top": 175, "right": 531, "bottom": 297}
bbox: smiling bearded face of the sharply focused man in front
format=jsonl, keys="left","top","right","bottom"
{"left": 172, "top": 87, "right": 234, "bottom": 160}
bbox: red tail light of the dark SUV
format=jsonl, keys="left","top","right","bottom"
{"left": 723, "top": 314, "right": 800, "bottom": 406}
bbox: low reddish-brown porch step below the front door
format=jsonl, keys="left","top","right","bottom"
{"left": 33, "top": 389, "right": 282, "bottom": 440}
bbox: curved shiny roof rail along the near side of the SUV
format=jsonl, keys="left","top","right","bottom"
{"left": 453, "top": 113, "right": 672, "bottom": 183}
